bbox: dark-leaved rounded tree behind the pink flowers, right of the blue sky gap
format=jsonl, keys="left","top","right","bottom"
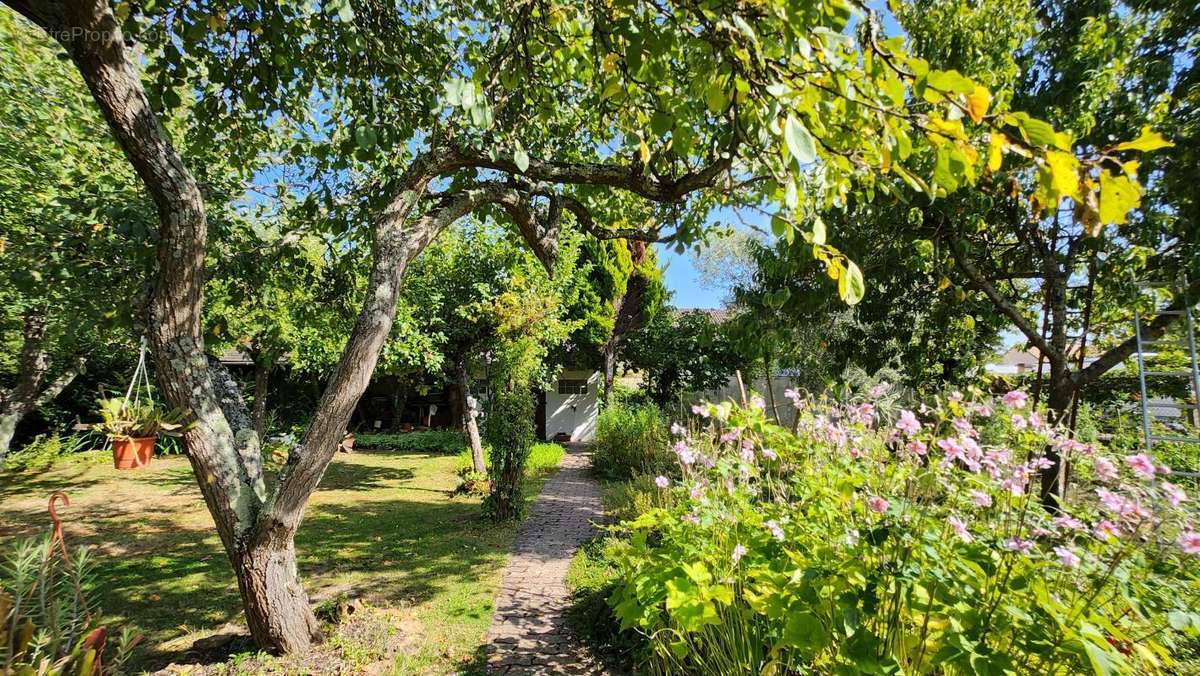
{"left": 731, "top": 202, "right": 1008, "bottom": 389}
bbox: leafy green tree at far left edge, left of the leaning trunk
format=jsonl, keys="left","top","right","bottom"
{"left": 0, "top": 13, "right": 152, "bottom": 463}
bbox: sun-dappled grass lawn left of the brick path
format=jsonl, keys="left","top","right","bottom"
{"left": 0, "top": 444, "right": 562, "bottom": 674}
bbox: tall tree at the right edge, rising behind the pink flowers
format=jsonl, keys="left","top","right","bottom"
{"left": 900, "top": 0, "right": 1200, "bottom": 501}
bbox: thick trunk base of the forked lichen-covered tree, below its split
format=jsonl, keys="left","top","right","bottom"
{"left": 234, "top": 533, "right": 320, "bottom": 653}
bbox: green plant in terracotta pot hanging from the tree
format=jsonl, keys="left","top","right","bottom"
{"left": 92, "top": 396, "right": 187, "bottom": 469}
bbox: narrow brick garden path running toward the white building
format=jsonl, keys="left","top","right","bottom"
{"left": 487, "top": 445, "right": 604, "bottom": 674}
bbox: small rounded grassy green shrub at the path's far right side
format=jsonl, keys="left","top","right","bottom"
{"left": 592, "top": 405, "right": 674, "bottom": 479}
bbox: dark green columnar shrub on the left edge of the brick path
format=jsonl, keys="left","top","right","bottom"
{"left": 484, "top": 390, "right": 535, "bottom": 521}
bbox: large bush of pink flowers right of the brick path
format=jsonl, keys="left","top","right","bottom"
{"left": 610, "top": 388, "right": 1200, "bottom": 674}
